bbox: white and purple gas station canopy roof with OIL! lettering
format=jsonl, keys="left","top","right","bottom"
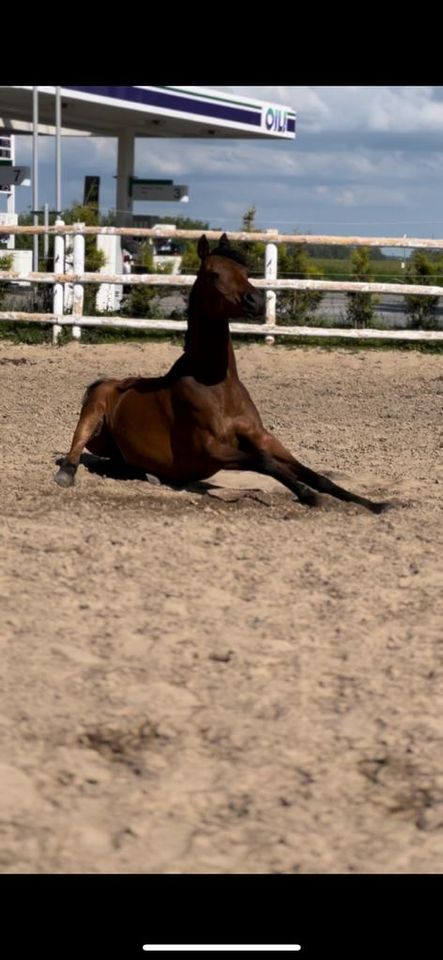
{"left": 0, "top": 85, "right": 295, "bottom": 140}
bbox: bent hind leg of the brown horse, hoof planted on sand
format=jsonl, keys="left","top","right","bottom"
{"left": 54, "top": 380, "right": 113, "bottom": 487}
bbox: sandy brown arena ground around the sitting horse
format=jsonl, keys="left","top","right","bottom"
{"left": 0, "top": 342, "right": 443, "bottom": 873}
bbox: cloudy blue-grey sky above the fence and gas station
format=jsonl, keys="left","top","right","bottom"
{"left": 0, "top": 86, "right": 443, "bottom": 244}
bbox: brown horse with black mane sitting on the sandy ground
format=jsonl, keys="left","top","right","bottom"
{"left": 55, "top": 234, "right": 387, "bottom": 513}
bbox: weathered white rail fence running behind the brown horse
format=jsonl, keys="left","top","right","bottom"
{"left": 0, "top": 221, "right": 443, "bottom": 343}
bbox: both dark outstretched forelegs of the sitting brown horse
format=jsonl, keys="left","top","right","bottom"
{"left": 239, "top": 433, "right": 389, "bottom": 513}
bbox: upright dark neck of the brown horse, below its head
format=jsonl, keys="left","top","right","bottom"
{"left": 185, "top": 308, "right": 238, "bottom": 383}
